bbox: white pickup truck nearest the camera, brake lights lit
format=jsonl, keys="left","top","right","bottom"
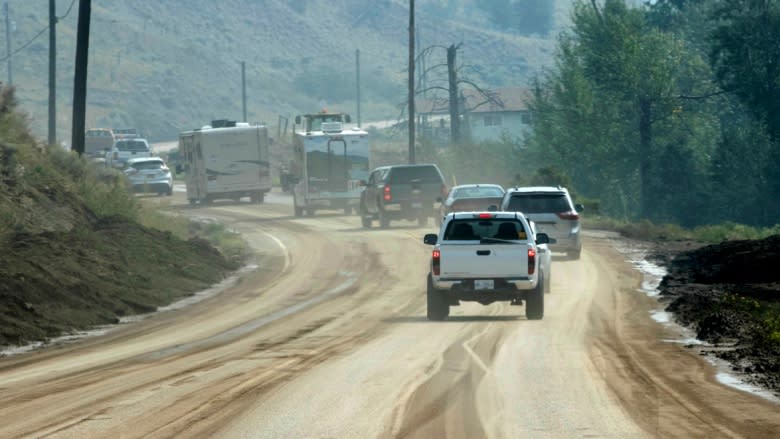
{"left": 423, "top": 212, "right": 552, "bottom": 320}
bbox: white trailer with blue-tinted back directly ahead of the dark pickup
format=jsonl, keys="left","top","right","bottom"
{"left": 290, "top": 113, "right": 371, "bottom": 216}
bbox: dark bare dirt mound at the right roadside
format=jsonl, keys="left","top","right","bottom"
{"left": 660, "top": 236, "right": 780, "bottom": 392}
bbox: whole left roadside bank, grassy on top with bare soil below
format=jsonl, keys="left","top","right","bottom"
{"left": 0, "top": 88, "right": 246, "bottom": 347}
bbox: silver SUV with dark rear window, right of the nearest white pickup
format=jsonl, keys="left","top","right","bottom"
{"left": 501, "top": 186, "right": 583, "bottom": 259}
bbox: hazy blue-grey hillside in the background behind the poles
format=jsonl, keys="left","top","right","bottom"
{"left": 0, "top": 0, "right": 570, "bottom": 141}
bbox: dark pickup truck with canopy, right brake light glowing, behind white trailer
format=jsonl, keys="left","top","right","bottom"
{"left": 360, "top": 164, "right": 447, "bottom": 228}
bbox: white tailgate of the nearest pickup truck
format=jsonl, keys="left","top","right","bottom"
{"left": 441, "top": 242, "right": 528, "bottom": 279}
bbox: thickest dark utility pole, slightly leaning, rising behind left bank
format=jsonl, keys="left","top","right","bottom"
{"left": 71, "top": 0, "right": 92, "bottom": 155}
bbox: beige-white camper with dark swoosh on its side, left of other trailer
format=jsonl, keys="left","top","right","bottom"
{"left": 179, "top": 120, "right": 271, "bottom": 204}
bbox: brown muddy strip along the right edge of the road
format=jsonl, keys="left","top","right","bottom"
{"left": 588, "top": 241, "right": 778, "bottom": 438}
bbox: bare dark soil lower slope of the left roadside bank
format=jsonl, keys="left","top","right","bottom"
{"left": 0, "top": 218, "right": 237, "bottom": 345}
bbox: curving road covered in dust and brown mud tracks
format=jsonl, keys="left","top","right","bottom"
{"left": 0, "top": 193, "right": 780, "bottom": 438}
